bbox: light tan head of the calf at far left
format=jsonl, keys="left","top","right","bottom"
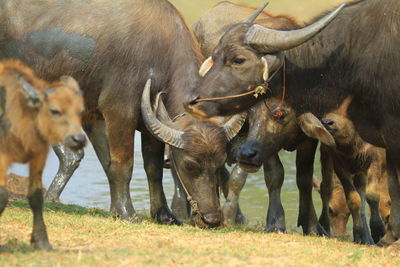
{"left": 19, "top": 76, "right": 86, "bottom": 149}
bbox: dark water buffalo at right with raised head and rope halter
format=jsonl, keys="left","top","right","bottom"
{"left": 187, "top": 0, "right": 400, "bottom": 247}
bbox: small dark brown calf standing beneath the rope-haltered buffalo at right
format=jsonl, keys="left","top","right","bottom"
{"left": 301, "top": 97, "right": 386, "bottom": 244}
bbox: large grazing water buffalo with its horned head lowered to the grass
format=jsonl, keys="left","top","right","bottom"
{"left": 0, "top": 0, "right": 252, "bottom": 228}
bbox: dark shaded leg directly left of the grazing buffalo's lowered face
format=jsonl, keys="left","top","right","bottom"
{"left": 142, "top": 132, "right": 181, "bottom": 225}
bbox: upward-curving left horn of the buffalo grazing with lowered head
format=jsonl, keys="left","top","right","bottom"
{"left": 140, "top": 79, "right": 184, "bottom": 149}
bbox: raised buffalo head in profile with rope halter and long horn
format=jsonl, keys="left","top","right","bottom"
{"left": 184, "top": 4, "right": 345, "bottom": 119}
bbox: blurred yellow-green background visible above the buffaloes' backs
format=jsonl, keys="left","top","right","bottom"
{"left": 170, "top": 0, "right": 351, "bottom": 25}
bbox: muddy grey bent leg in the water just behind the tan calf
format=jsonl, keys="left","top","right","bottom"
{"left": 44, "top": 144, "right": 84, "bottom": 202}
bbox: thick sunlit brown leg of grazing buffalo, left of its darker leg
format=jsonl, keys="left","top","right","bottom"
{"left": 85, "top": 118, "right": 140, "bottom": 222}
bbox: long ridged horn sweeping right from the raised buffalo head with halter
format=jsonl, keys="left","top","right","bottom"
{"left": 245, "top": 3, "right": 346, "bottom": 53}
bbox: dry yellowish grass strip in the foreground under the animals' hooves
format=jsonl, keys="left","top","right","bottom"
{"left": 0, "top": 202, "right": 400, "bottom": 267}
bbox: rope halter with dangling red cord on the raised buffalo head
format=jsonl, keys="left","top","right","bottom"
{"left": 193, "top": 59, "right": 286, "bottom": 118}
